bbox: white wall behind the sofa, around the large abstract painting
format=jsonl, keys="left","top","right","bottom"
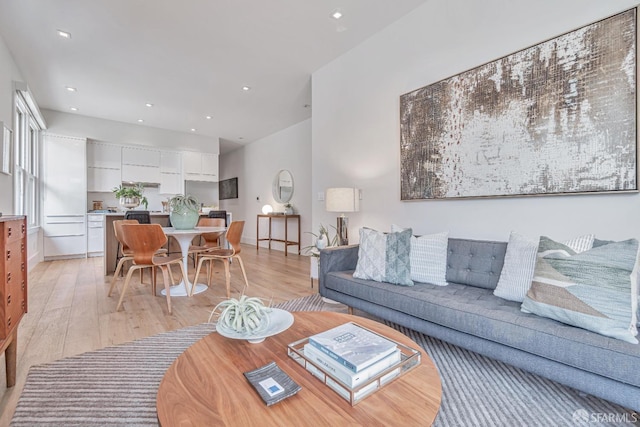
{"left": 311, "top": 0, "right": 640, "bottom": 243}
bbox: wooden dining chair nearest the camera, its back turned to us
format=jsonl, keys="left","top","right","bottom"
{"left": 109, "top": 224, "right": 188, "bottom": 314}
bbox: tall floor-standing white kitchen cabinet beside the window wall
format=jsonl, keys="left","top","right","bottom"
{"left": 42, "top": 134, "right": 87, "bottom": 260}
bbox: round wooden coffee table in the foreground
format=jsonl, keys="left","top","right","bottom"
{"left": 157, "top": 311, "right": 442, "bottom": 426}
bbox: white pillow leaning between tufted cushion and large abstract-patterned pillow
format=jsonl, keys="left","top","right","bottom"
{"left": 493, "top": 231, "right": 538, "bottom": 302}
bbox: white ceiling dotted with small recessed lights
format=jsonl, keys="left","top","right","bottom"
{"left": 0, "top": 0, "right": 426, "bottom": 152}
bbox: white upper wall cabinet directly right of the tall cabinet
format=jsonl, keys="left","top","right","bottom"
{"left": 87, "top": 141, "right": 122, "bottom": 192}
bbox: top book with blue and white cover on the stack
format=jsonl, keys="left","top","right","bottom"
{"left": 309, "top": 322, "right": 397, "bottom": 372}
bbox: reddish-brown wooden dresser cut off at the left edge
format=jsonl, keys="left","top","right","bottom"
{"left": 0, "top": 216, "right": 27, "bottom": 387}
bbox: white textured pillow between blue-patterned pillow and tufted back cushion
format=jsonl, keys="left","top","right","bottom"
{"left": 391, "top": 224, "right": 449, "bottom": 286}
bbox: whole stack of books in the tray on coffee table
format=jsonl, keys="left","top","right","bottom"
{"left": 304, "top": 322, "right": 401, "bottom": 400}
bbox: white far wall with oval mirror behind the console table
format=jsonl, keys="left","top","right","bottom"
{"left": 220, "top": 119, "right": 311, "bottom": 251}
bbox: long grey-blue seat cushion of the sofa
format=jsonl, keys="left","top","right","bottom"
{"left": 325, "top": 271, "right": 640, "bottom": 387}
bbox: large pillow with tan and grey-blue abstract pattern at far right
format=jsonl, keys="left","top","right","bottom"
{"left": 522, "top": 236, "right": 639, "bottom": 343}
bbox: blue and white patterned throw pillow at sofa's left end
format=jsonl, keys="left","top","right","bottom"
{"left": 353, "top": 227, "right": 413, "bottom": 286}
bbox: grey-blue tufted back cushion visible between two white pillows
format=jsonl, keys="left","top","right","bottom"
{"left": 446, "top": 238, "right": 507, "bottom": 289}
